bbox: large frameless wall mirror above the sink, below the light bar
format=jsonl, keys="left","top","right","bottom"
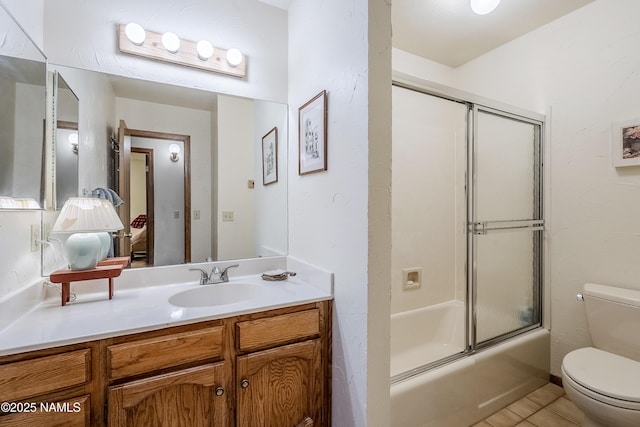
{"left": 52, "top": 65, "right": 288, "bottom": 267}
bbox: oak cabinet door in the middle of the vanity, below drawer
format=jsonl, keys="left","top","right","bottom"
{"left": 108, "top": 362, "right": 228, "bottom": 427}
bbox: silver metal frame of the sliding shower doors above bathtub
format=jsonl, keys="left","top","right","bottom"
{"left": 391, "top": 72, "right": 546, "bottom": 384}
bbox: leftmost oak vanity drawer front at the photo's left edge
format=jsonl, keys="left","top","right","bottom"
{"left": 0, "top": 349, "right": 91, "bottom": 402}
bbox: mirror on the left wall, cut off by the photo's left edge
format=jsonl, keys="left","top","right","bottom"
{"left": 0, "top": 4, "right": 46, "bottom": 209}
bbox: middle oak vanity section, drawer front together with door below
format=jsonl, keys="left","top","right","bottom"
{"left": 105, "top": 320, "right": 230, "bottom": 427}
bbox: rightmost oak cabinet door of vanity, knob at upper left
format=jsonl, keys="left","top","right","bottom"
{"left": 236, "top": 339, "right": 325, "bottom": 427}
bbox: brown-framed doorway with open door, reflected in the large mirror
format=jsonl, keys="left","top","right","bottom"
{"left": 117, "top": 121, "right": 191, "bottom": 266}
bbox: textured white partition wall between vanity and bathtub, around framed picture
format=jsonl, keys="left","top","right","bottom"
{"left": 289, "top": 0, "right": 391, "bottom": 427}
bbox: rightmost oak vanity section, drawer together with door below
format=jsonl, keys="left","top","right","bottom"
{"left": 236, "top": 305, "right": 330, "bottom": 427}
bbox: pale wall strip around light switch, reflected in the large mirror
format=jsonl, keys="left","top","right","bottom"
{"left": 215, "top": 95, "right": 254, "bottom": 260}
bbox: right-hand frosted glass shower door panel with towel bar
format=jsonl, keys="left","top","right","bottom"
{"left": 468, "top": 106, "right": 544, "bottom": 348}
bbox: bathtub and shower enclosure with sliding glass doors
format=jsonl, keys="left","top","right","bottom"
{"left": 391, "top": 76, "right": 549, "bottom": 427}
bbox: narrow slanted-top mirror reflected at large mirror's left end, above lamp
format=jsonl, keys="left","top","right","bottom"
{"left": 53, "top": 72, "right": 79, "bottom": 210}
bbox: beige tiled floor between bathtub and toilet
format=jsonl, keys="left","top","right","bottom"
{"left": 473, "top": 383, "right": 584, "bottom": 427}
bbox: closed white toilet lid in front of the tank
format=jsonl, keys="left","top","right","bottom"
{"left": 562, "top": 347, "right": 640, "bottom": 402}
